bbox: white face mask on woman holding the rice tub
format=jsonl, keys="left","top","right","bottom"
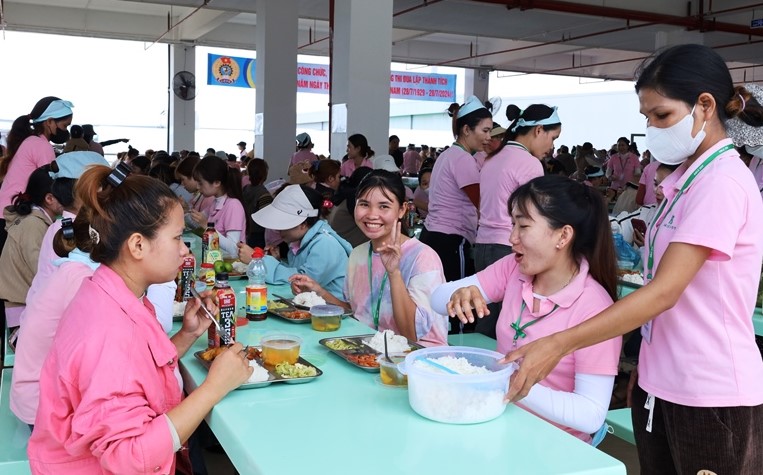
{"left": 646, "top": 105, "right": 707, "bottom": 165}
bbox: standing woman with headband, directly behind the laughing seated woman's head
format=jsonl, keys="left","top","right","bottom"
{"left": 474, "top": 104, "right": 562, "bottom": 338}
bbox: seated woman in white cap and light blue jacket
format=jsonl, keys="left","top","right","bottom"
{"left": 239, "top": 185, "right": 352, "bottom": 297}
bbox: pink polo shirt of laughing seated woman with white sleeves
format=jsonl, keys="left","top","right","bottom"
{"left": 477, "top": 254, "right": 622, "bottom": 441}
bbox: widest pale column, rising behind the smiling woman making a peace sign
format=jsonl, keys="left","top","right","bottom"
{"left": 331, "top": 0, "right": 393, "bottom": 160}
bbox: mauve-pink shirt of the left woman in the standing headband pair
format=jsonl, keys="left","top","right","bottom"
{"left": 425, "top": 145, "right": 480, "bottom": 243}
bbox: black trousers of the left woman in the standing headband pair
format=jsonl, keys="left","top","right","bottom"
{"left": 419, "top": 227, "right": 476, "bottom": 333}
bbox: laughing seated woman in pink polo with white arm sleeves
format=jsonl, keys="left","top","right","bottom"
{"left": 432, "top": 175, "right": 621, "bottom": 442}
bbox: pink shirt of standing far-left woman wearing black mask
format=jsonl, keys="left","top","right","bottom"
{"left": 0, "top": 135, "right": 56, "bottom": 210}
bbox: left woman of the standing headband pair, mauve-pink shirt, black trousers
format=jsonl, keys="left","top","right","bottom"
{"left": 420, "top": 96, "right": 493, "bottom": 288}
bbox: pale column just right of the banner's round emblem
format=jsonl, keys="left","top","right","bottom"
{"left": 254, "top": 0, "right": 298, "bottom": 178}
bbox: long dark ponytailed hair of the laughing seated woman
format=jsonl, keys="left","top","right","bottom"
{"left": 509, "top": 175, "right": 617, "bottom": 301}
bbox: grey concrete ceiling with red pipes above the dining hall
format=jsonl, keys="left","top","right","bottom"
{"left": 0, "top": 0, "right": 763, "bottom": 82}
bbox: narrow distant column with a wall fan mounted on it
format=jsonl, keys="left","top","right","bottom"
{"left": 167, "top": 45, "right": 196, "bottom": 153}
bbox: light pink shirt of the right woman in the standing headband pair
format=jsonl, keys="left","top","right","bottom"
{"left": 477, "top": 144, "right": 543, "bottom": 246}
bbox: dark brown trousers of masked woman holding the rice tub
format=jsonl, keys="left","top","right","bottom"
{"left": 631, "top": 385, "right": 763, "bottom": 475}
